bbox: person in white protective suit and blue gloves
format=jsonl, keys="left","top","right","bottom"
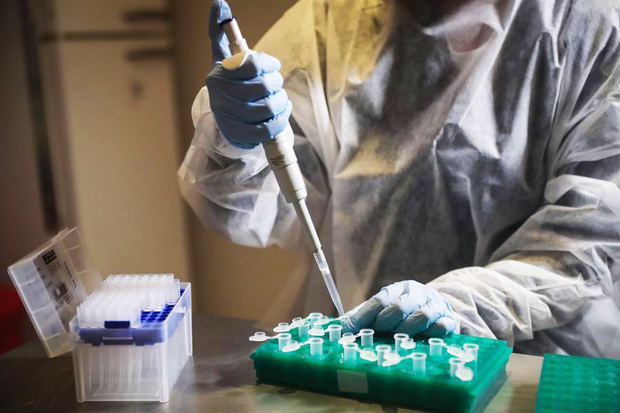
{"left": 179, "top": 0, "right": 620, "bottom": 358}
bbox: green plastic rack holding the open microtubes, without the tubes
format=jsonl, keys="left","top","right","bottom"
{"left": 251, "top": 320, "right": 512, "bottom": 412}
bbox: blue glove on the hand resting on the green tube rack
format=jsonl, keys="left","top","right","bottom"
{"left": 342, "top": 281, "right": 458, "bottom": 337}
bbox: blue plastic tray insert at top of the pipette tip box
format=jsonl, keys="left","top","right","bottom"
{"left": 79, "top": 289, "right": 186, "bottom": 346}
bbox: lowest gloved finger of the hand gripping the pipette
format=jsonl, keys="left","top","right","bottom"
{"left": 215, "top": 101, "right": 293, "bottom": 148}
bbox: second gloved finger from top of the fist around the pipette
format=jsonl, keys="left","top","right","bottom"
{"left": 207, "top": 71, "right": 284, "bottom": 102}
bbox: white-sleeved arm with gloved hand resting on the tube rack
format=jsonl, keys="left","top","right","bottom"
{"left": 344, "top": 4, "right": 620, "bottom": 344}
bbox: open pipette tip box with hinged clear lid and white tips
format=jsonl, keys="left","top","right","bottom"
{"left": 8, "top": 228, "right": 192, "bottom": 402}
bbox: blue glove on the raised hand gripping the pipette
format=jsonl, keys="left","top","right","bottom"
{"left": 206, "top": 0, "right": 293, "bottom": 149}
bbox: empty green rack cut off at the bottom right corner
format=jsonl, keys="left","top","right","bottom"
{"left": 536, "top": 354, "right": 620, "bottom": 413}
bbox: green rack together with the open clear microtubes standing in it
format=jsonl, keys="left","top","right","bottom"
{"left": 250, "top": 316, "right": 512, "bottom": 412}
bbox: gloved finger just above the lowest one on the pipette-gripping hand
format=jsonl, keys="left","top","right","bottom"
{"left": 211, "top": 89, "right": 288, "bottom": 123}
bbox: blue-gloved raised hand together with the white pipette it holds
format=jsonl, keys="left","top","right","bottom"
{"left": 206, "top": 1, "right": 344, "bottom": 315}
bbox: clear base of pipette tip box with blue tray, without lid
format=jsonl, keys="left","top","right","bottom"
{"left": 72, "top": 283, "right": 192, "bottom": 402}
